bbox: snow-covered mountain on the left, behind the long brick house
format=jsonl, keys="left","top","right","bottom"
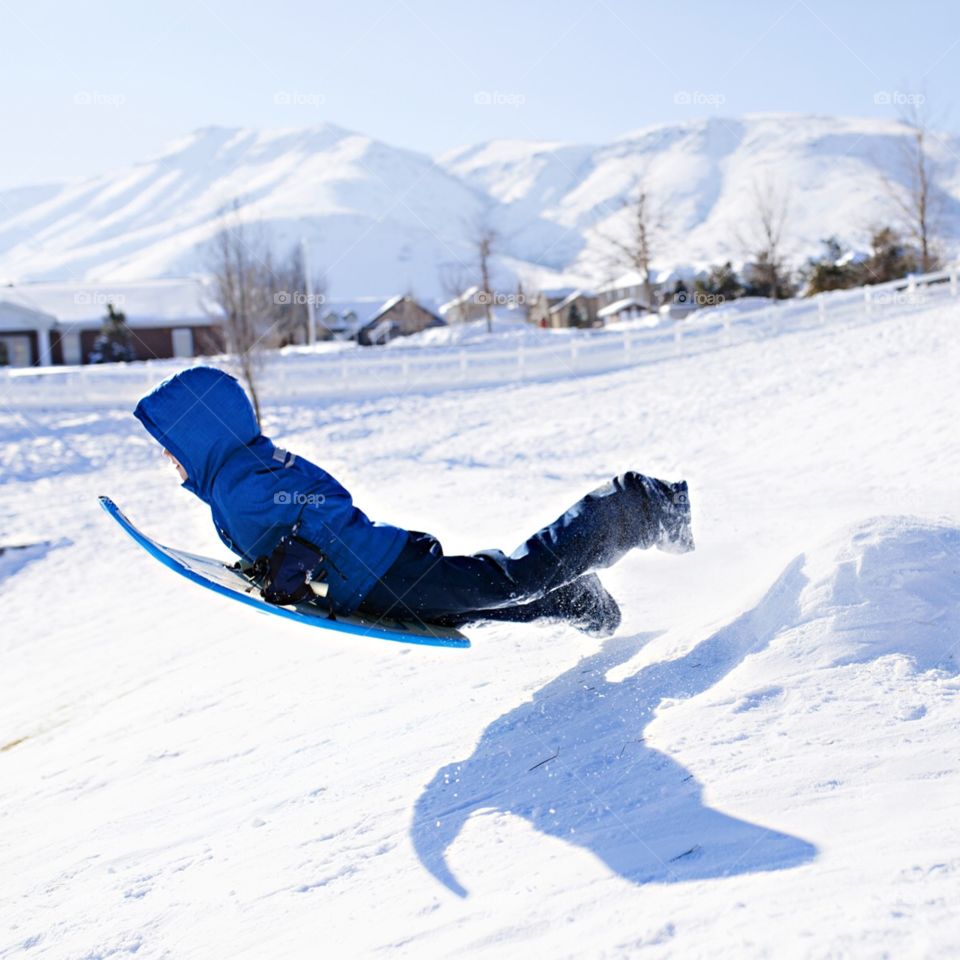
{"left": 0, "top": 124, "right": 492, "bottom": 295}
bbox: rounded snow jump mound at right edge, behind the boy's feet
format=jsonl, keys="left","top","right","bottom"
{"left": 798, "top": 516, "right": 960, "bottom": 675}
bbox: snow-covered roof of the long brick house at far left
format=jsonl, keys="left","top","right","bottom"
{"left": 0, "top": 278, "right": 219, "bottom": 327}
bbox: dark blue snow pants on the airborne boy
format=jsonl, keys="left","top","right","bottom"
{"left": 359, "top": 472, "right": 674, "bottom": 625}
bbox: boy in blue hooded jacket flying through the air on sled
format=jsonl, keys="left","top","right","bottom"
{"left": 134, "top": 367, "right": 693, "bottom": 636}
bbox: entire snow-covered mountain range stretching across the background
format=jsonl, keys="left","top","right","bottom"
{"left": 0, "top": 114, "right": 960, "bottom": 296}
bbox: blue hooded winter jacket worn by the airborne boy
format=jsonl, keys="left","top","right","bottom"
{"left": 134, "top": 367, "right": 407, "bottom": 613}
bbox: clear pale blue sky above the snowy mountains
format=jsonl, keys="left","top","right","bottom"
{"left": 0, "top": 0, "right": 960, "bottom": 187}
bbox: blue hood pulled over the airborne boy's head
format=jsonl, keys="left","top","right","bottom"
{"left": 133, "top": 367, "right": 260, "bottom": 503}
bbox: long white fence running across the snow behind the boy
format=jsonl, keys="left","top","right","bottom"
{"left": 0, "top": 266, "right": 960, "bottom": 409}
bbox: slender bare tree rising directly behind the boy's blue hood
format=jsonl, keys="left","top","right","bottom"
{"left": 208, "top": 200, "right": 274, "bottom": 423}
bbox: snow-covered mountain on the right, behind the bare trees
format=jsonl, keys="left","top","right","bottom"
{"left": 441, "top": 114, "right": 960, "bottom": 276}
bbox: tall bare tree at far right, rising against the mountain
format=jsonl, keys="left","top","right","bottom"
{"left": 881, "top": 100, "right": 943, "bottom": 273}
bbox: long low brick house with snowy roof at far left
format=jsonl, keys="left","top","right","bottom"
{"left": 0, "top": 279, "right": 224, "bottom": 366}
